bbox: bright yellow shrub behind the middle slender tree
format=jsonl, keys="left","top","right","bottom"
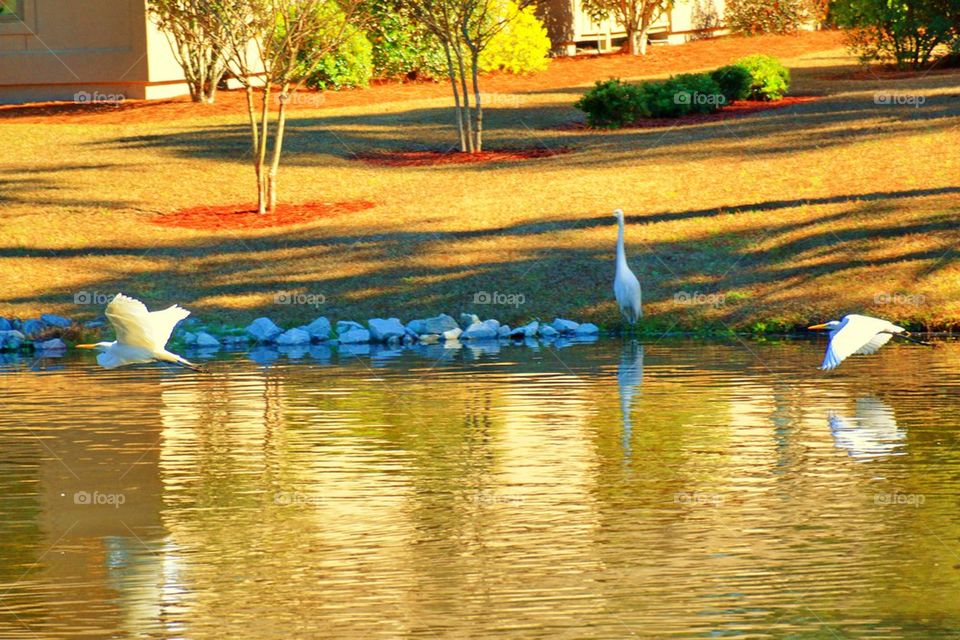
{"left": 480, "top": 2, "right": 551, "bottom": 73}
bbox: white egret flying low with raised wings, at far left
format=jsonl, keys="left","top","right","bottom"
{"left": 77, "top": 293, "right": 203, "bottom": 371}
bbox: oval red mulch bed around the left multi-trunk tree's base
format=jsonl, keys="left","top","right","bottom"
{"left": 151, "top": 200, "right": 375, "bottom": 231}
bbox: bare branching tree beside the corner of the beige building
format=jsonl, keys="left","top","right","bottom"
{"left": 147, "top": 0, "right": 226, "bottom": 104}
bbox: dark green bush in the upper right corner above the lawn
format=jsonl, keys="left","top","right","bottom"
{"left": 832, "top": 0, "right": 960, "bottom": 68}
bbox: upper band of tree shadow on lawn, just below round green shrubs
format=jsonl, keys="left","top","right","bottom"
{"left": 84, "top": 87, "right": 960, "bottom": 172}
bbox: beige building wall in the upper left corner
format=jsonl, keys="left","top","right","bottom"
{"left": 0, "top": 0, "right": 188, "bottom": 104}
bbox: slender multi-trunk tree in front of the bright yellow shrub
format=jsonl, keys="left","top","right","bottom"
{"left": 408, "top": 0, "right": 533, "bottom": 153}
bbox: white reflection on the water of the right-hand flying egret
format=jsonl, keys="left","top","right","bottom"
{"left": 827, "top": 396, "right": 907, "bottom": 461}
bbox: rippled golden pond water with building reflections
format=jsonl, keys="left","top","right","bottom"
{"left": 0, "top": 340, "right": 960, "bottom": 639}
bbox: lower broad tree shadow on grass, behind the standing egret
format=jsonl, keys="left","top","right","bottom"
{"left": 7, "top": 187, "right": 960, "bottom": 326}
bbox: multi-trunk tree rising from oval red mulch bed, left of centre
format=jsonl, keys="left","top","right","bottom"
{"left": 215, "top": 0, "right": 362, "bottom": 213}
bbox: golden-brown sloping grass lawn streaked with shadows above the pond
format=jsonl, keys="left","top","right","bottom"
{"left": 0, "top": 33, "right": 960, "bottom": 332}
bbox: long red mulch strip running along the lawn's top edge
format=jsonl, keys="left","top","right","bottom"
{"left": 0, "top": 31, "right": 843, "bottom": 124}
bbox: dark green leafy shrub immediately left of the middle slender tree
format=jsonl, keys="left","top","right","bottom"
{"left": 364, "top": 0, "right": 447, "bottom": 80}
